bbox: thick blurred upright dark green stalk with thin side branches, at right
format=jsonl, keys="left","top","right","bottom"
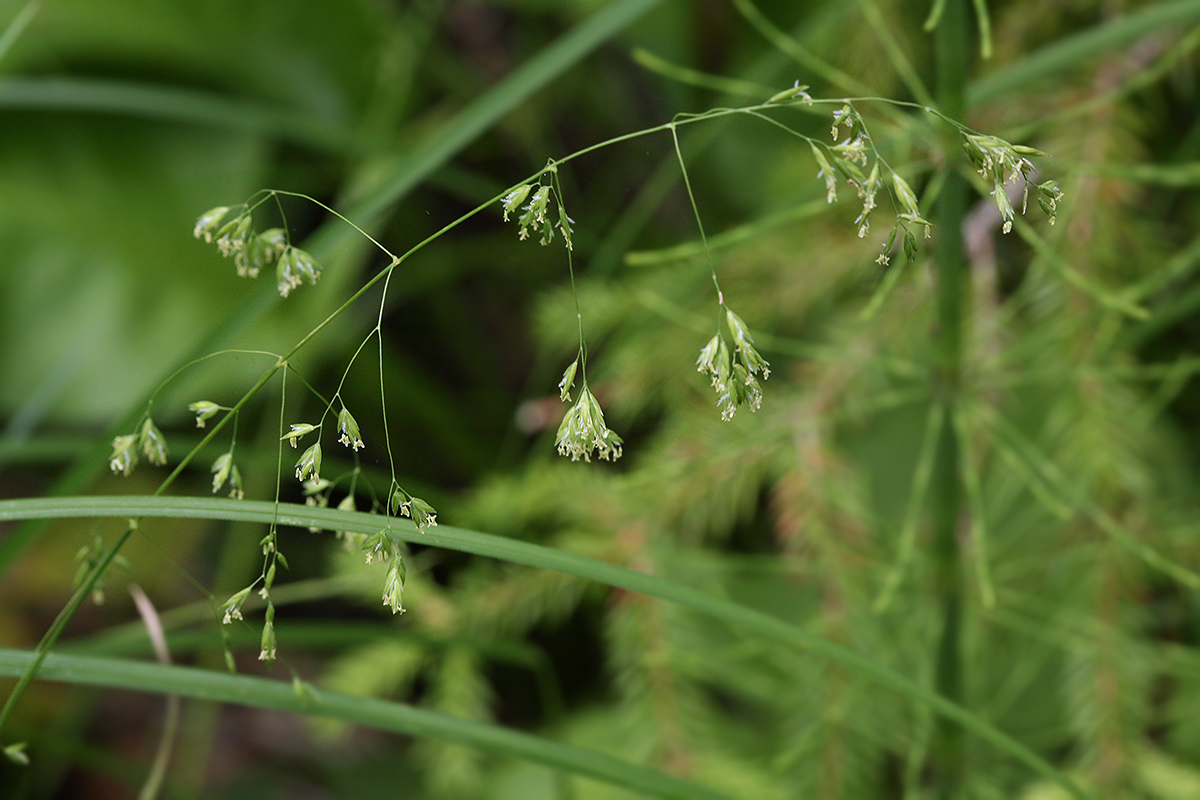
{"left": 930, "top": 0, "right": 971, "bottom": 800}
